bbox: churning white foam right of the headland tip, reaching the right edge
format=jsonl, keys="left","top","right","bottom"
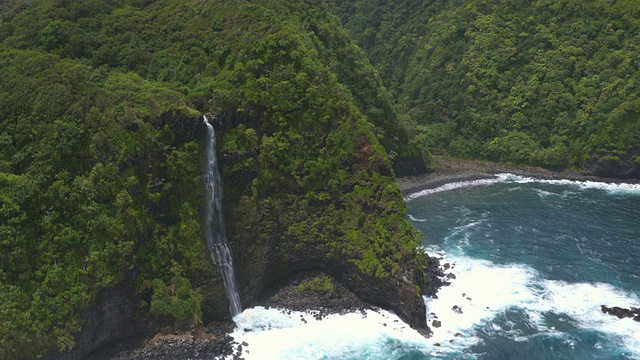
{"left": 427, "top": 247, "right": 640, "bottom": 358}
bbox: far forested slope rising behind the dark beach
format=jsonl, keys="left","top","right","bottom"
{"left": 332, "top": 0, "right": 640, "bottom": 177}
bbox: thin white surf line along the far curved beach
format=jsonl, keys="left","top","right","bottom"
{"left": 405, "top": 173, "right": 640, "bottom": 201}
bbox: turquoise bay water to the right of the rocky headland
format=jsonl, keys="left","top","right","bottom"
{"left": 408, "top": 177, "right": 640, "bottom": 359}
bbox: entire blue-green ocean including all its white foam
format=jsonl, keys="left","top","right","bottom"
{"left": 232, "top": 174, "right": 640, "bottom": 360}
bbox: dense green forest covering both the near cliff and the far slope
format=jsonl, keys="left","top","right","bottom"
{"left": 5, "top": 0, "right": 640, "bottom": 359}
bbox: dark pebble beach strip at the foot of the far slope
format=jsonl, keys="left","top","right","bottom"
{"left": 397, "top": 157, "right": 640, "bottom": 197}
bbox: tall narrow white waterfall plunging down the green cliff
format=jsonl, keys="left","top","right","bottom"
{"left": 203, "top": 116, "right": 242, "bottom": 317}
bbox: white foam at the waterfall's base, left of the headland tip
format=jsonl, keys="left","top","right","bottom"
{"left": 231, "top": 307, "right": 432, "bottom": 360}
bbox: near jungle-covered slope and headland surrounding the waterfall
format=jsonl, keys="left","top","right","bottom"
{"left": 0, "top": 0, "right": 426, "bottom": 359}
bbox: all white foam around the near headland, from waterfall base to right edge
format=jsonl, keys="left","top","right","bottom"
{"left": 222, "top": 246, "right": 640, "bottom": 360}
